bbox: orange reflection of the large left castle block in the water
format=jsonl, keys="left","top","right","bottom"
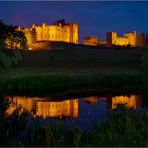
{"left": 5, "top": 97, "right": 78, "bottom": 119}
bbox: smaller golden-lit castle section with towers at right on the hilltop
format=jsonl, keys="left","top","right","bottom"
{"left": 106, "top": 31, "right": 136, "bottom": 47}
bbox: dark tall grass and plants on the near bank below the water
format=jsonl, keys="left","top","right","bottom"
{"left": 0, "top": 105, "right": 148, "bottom": 147}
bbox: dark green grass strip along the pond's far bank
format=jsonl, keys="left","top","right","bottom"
{"left": 0, "top": 69, "right": 141, "bottom": 95}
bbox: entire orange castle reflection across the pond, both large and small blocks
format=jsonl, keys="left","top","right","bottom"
{"left": 5, "top": 95, "right": 142, "bottom": 119}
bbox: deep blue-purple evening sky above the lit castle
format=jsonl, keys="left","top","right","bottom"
{"left": 0, "top": 1, "right": 148, "bottom": 42}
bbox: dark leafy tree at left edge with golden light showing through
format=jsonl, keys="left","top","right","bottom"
{"left": 0, "top": 20, "right": 27, "bottom": 69}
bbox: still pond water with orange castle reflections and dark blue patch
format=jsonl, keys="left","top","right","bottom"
{"left": 5, "top": 94, "right": 147, "bottom": 128}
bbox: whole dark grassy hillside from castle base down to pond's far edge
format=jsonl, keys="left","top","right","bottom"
{"left": 0, "top": 49, "right": 142, "bottom": 94}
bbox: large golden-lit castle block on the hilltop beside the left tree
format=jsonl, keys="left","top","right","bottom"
{"left": 22, "top": 20, "right": 78, "bottom": 48}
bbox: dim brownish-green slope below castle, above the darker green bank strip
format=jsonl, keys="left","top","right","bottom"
{"left": 1, "top": 49, "right": 143, "bottom": 77}
